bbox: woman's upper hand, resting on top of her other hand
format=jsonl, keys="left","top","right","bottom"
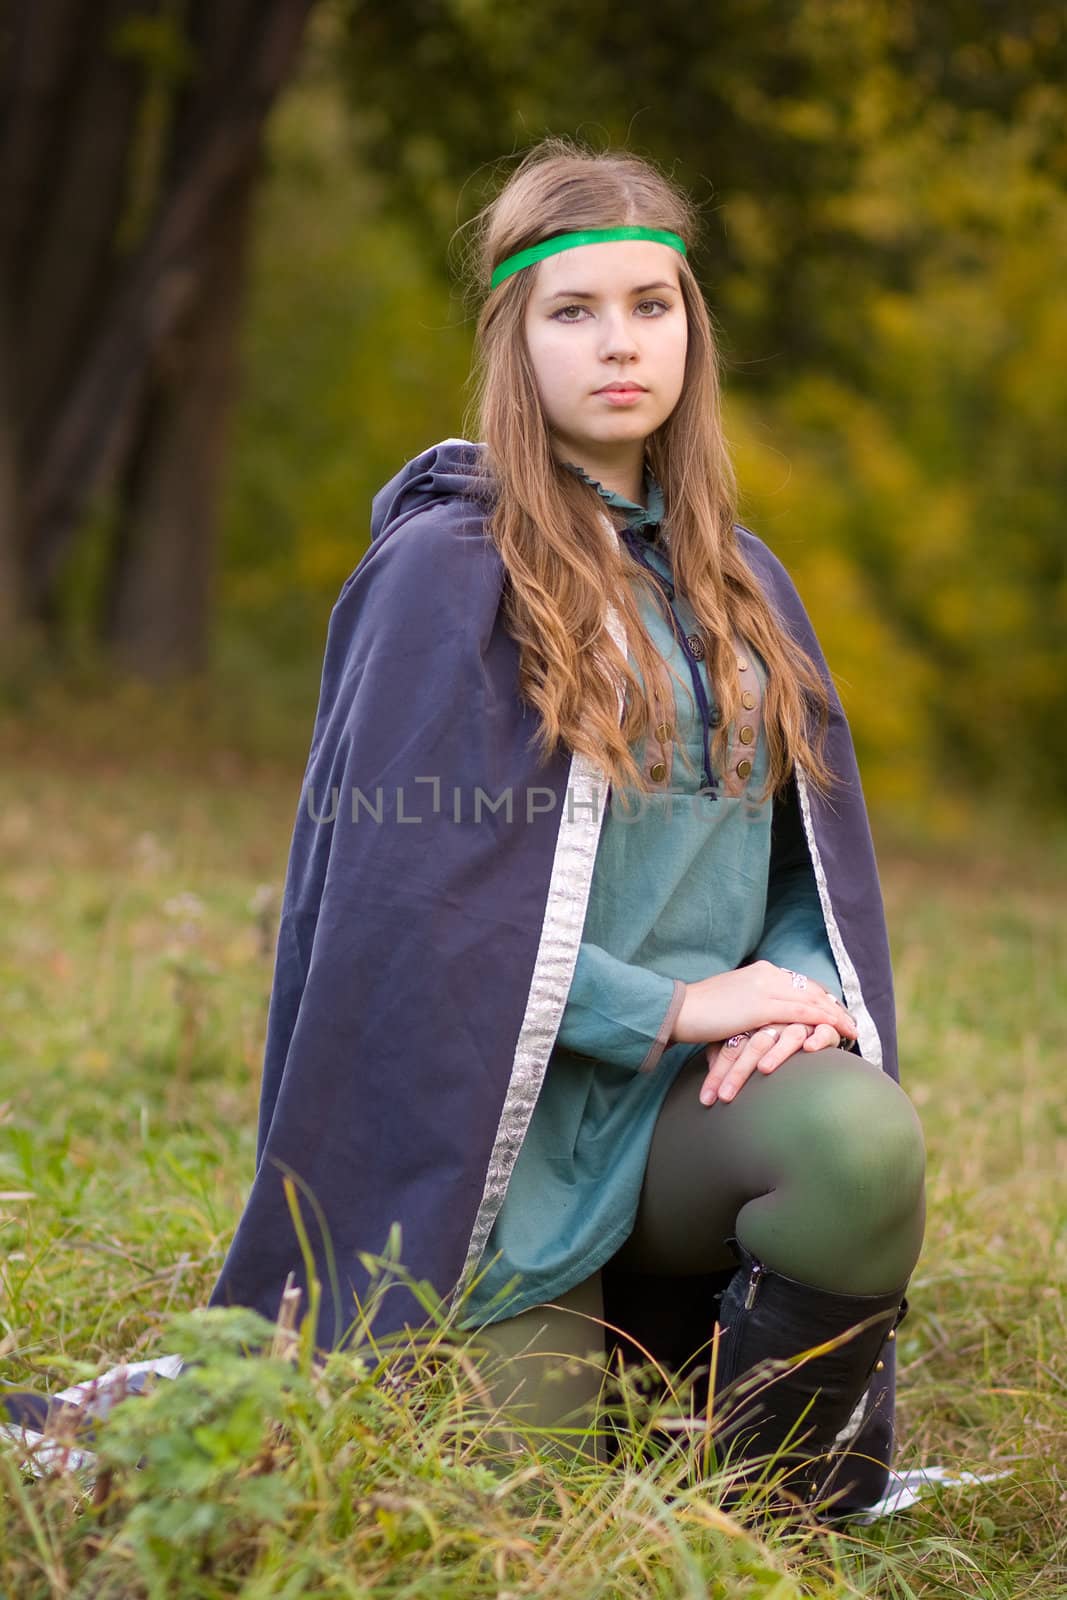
{"left": 672, "top": 962, "right": 856, "bottom": 1049}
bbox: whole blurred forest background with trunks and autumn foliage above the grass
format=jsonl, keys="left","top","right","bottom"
{"left": 0, "top": 0, "right": 1067, "bottom": 838}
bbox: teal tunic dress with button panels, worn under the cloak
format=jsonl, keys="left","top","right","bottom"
{"left": 459, "top": 469, "right": 841, "bottom": 1328}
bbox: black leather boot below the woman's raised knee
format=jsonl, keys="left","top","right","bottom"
{"left": 712, "top": 1240, "right": 907, "bottom": 1504}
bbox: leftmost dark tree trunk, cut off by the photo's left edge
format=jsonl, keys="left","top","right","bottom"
{"left": 0, "top": 0, "right": 144, "bottom": 632}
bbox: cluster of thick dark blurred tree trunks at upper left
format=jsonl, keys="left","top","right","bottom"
{"left": 0, "top": 0, "right": 314, "bottom": 675}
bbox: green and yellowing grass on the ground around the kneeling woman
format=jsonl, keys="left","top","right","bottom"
{"left": 0, "top": 720, "right": 1067, "bottom": 1600}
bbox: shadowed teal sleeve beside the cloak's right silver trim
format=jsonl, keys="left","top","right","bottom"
{"left": 752, "top": 784, "right": 843, "bottom": 1000}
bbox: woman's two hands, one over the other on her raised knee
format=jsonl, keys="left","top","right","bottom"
{"left": 673, "top": 962, "right": 856, "bottom": 1106}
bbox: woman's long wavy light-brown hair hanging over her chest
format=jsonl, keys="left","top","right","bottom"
{"left": 467, "top": 139, "right": 830, "bottom": 797}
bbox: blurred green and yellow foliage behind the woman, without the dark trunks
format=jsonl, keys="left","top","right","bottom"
{"left": 2, "top": 0, "right": 1067, "bottom": 837}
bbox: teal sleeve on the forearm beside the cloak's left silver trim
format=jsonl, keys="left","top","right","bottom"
{"left": 557, "top": 941, "right": 685, "bottom": 1072}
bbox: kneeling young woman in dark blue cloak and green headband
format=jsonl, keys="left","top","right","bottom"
{"left": 207, "top": 141, "right": 923, "bottom": 1504}
